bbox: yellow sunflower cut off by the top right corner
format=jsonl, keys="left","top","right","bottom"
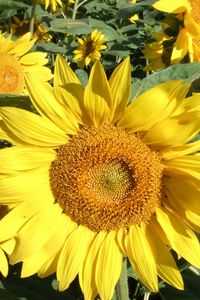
{"left": 153, "top": 0, "right": 200, "bottom": 63}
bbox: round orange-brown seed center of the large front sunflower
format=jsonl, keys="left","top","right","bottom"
{"left": 50, "top": 125, "right": 163, "bottom": 232}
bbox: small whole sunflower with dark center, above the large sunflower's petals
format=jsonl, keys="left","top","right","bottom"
{"left": 73, "top": 29, "right": 107, "bottom": 67}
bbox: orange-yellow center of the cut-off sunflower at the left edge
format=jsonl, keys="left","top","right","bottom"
{"left": 0, "top": 54, "right": 24, "bottom": 94}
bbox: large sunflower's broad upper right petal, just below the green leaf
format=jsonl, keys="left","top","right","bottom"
{"left": 118, "top": 80, "right": 189, "bottom": 131}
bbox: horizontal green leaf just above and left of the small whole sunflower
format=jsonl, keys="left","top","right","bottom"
{"left": 49, "top": 19, "right": 92, "bottom": 35}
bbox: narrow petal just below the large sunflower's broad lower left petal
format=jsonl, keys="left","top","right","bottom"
{"left": 21, "top": 214, "right": 77, "bottom": 277}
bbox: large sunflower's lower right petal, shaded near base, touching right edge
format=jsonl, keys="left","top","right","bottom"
{"left": 156, "top": 208, "right": 200, "bottom": 267}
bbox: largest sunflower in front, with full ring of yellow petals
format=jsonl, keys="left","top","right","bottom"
{"left": 0, "top": 57, "right": 200, "bottom": 300}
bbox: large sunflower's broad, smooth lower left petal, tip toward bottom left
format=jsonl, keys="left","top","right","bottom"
{"left": 10, "top": 204, "right": 62, "bottom": 264}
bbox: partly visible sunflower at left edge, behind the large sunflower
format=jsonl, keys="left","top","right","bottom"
{"left": 0, "top": 33, "right": 52, "bottom": 94}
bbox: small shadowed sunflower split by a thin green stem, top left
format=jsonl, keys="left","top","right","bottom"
{"left": 11, "top": 16, "right": 52, "bottom": 42}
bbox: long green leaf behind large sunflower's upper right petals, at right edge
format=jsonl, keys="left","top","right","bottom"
{"left": 132, "top": 63, "right": 200, "bottom": 99}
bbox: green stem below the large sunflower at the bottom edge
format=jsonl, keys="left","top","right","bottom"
{"left": 115, "top": 257, "right": 129, "bottom": 300}
